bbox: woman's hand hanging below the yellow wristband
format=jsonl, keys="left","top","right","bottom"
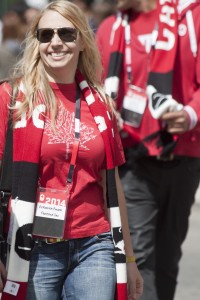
{"left": 127, "top": 262, "right": 143, "bottom": 300}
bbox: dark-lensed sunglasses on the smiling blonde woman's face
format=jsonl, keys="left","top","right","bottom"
{"left": 36, "top": 27, "right": 78, "bottom": 43}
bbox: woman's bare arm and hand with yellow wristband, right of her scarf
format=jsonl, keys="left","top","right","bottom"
{"left": 115, "top": 168, "right": 143, "bottom": 300}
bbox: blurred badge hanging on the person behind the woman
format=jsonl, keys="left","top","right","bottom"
{"left": 121, "top": 85, "right": 147, "bottom": 128}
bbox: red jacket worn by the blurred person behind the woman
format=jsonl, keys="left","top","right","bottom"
{"left": 97, "top": 0, "right": 200, "bottom": 157}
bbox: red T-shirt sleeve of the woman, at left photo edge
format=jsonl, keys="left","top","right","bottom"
{"left": 0, "top": 82, "right": 11, "bottom": 160}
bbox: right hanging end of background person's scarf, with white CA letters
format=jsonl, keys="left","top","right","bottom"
{"left": 145, "top": 0, "right": 178, "bottom": 157}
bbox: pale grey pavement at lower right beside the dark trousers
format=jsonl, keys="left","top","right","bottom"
{"left": 173, "top": 188, "right": 200, "bottom": 300}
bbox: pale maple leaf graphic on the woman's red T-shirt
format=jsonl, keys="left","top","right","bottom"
{"left": 45, "top": 103, "right": 96, "bottom": 153}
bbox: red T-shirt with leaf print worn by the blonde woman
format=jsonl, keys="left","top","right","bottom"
{"left": 0, "top": 83, "right": 124, "bottom": 239}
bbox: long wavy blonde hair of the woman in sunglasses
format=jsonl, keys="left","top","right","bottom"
{"left": 10, "top": 0, "right": 112, "bottom": 120}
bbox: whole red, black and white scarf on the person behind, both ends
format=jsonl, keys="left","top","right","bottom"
{"left": 105, "top": 0, "right": 177, "bottom": 154}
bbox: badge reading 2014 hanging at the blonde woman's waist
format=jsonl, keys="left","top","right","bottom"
{"left": 32, "top": 187, "right": 69, "bottom": 238}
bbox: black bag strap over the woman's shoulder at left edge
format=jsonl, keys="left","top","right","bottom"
{"left": 0, "top": 83, "right": 14, "bottom": 199}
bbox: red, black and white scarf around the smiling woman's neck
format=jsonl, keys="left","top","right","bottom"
{"left": 2, "top": 71, "right": 128, "bottom": 300}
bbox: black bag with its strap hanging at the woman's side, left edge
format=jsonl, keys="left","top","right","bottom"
{"left": 0, "top": 82, "right": 13, "bottom": 264}
